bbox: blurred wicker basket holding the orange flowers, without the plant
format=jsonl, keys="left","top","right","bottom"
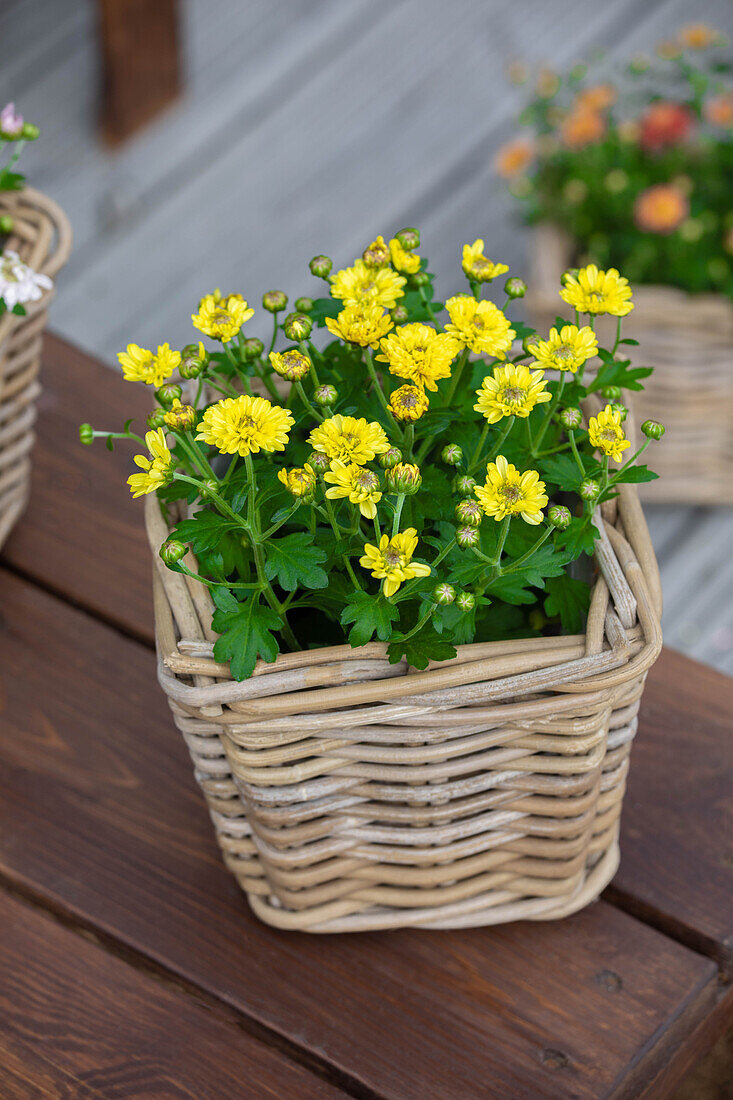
{"left": 526, "top": 226, "right": 733, "bottom": 505}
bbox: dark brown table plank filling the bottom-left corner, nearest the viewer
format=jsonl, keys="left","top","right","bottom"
{"left": 0, "top": 891, "right": 346, "bottom": 1100}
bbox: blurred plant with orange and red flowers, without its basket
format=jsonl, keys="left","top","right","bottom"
{"left": 494, "top": 23, "right": 733, "bottom": 297}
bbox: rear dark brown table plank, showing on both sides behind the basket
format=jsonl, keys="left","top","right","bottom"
{"left": 3, "top": 336, "right": 733, "bottom": 981}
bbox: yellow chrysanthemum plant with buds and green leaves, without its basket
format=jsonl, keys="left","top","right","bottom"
{"left": 80, "top": 229, "right": 664, "bottom": 679}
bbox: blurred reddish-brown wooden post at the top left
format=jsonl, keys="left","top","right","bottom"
{"left": 97, "top": 0, "right": 180, "bottom": 145}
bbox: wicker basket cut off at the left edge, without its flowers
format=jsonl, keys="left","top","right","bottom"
{"left": 0, "top": 187, "right": 72, "bottom": 546}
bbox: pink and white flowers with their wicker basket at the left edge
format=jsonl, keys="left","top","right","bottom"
{"left": 0, "top": 103, "right": 70, "bottom": 546}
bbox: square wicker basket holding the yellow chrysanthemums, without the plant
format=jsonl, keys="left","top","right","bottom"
{"left": 145, "top": 468, "right": 661, "bottom": 932}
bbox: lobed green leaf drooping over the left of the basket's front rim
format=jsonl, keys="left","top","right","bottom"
{"left": 211, "top": 590, "right": 282, "bottom": 680}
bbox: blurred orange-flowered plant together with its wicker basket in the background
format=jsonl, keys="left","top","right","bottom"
{"left": 495, "top": 24, "right": 733, "bottom": 504}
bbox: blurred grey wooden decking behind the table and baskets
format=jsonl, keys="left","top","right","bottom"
{"left": 0, "top": 0, "right": 733, "bottom": 672}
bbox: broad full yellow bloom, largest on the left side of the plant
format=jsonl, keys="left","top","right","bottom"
{"left": 196, "top": 394, "right": 294, "bottom": 458}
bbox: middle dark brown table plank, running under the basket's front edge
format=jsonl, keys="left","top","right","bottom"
{"left": 0, "top": 573, "right": 718, "bottom": 1100}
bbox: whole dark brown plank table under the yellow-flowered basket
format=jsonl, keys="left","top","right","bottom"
{"left": 0, "top": 337, "right": 733, "bottom": 1100}
